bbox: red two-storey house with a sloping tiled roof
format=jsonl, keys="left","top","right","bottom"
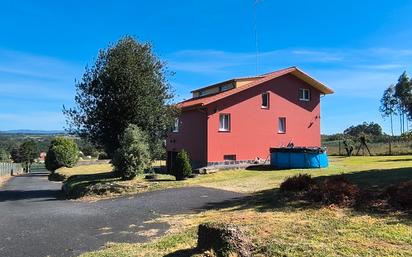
{"left": 166, "top": 67, "right": 333, "bottom": 168}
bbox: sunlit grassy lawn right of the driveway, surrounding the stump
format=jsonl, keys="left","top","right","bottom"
{"left": 77, "top": 156, "right": 412, "bottom": 257}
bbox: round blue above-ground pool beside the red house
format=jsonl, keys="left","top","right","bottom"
{"left": 270, "top": 147, "right": 329, "bottom": 169}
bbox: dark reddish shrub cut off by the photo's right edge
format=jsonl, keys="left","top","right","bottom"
{"left": 386, "top": 180, "right": 412, "bottom": 210}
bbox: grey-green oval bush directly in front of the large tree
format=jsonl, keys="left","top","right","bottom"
{"left": 112, "top": 125, "right": 151, "bottom": 180}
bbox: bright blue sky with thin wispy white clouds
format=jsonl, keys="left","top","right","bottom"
{"left": 0, "top": 0, "right": 412, "bottom": 133}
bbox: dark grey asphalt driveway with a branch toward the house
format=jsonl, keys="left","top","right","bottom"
{"left": 0, "top": 174, "right": 241, "bottom": 257}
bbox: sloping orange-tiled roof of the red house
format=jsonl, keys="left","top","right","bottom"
{"left": 177, "top": 67, "right": 333, "bottom": 109}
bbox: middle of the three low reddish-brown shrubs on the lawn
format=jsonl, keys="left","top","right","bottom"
{"left": 308, "top": 175, "right": 360, "bottom": 205}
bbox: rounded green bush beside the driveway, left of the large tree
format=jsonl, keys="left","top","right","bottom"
{"left": 45, "top": 137, "right": 79, "bottom": 172}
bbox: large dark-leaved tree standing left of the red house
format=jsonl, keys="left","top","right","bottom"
{"left": 63, "top": 36, "right": 176, "bottom": 158}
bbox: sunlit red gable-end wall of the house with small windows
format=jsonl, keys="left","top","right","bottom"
{"left": 206, "top": 75, "right": 320, "bottom": 162}
